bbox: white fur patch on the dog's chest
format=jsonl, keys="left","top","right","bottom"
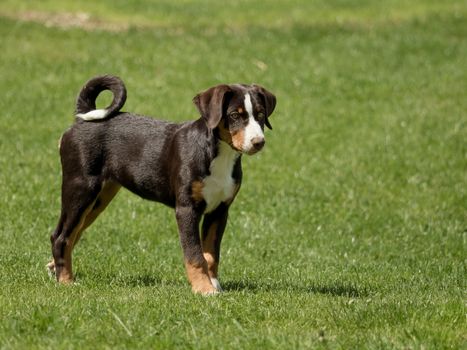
{"left": 203, "top": 141, "right": 239, "bottom": 213}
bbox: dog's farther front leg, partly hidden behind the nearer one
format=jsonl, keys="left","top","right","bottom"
{"left": 202, "top": 203, "right": 229, "bottom": 292}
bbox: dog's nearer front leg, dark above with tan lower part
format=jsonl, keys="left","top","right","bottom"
{"left": 175, "top": 206, "right": 217, "bottom": 295}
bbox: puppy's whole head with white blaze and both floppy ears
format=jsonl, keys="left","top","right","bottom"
{"left": 193, "top": 84, "right": 276, "bottom": 154}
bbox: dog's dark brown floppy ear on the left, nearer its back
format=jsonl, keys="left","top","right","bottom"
{"left": 193, "top": 85, "right": 232, "bottom": 129}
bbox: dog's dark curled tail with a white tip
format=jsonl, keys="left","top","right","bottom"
{"left": 76, "top": 75, "right": 126, "bottom": 120}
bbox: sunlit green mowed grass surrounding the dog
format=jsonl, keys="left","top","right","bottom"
{"left": 0, "top": 0, "right": 467, "bottom": 349}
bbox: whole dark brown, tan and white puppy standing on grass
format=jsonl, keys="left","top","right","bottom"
{"left": 48, "top": 75, "right": 276, "bottom": 294}
